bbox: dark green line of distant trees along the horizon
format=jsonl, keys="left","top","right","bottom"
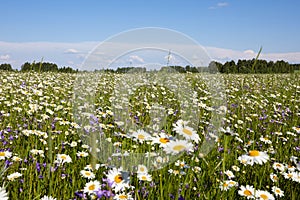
{"left": 0, "top": 59, "right": 300, "bottom": 74}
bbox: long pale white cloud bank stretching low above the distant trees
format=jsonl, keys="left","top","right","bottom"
{"left": 0, "top": 41, "right": 300, "bottom": 69}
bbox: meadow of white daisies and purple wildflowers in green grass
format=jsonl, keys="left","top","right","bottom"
{"left": 0, "top": 71, "right": 300, "bottom": 200}
